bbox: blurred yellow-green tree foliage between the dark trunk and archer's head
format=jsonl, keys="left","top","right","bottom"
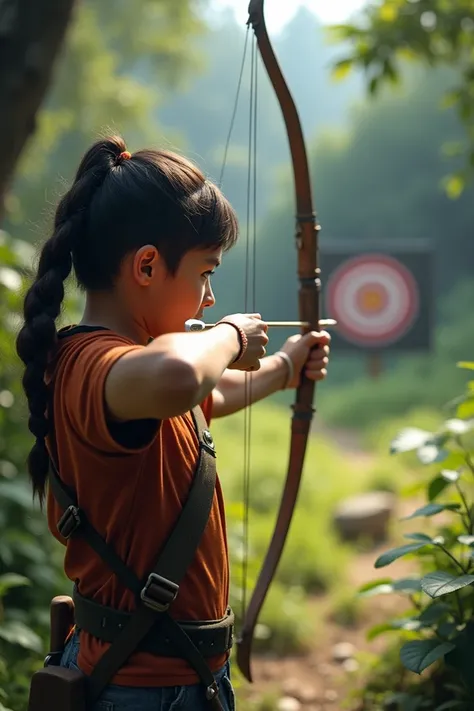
{"left": 6, "top": 0, "right": 204, "bottom": 239}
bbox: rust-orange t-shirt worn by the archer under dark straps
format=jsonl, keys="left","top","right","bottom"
{"left": 48, "top": 327, "right": 229, "bottom": 686}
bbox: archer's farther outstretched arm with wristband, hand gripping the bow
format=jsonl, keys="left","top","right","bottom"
{"left": 212, "top": 331, "right": 331, "bottom": 419}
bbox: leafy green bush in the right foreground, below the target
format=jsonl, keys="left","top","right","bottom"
{"left": 360, "top": 363, "right": 474, "bottom": 711}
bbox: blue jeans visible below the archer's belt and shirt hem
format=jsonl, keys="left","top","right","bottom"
{"left": 61, "top": 632, "right": 235, "bottom": 711}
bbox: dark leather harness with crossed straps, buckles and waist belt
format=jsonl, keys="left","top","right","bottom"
{"left": 49, "top": 407, "right": 234, "bottom": 711}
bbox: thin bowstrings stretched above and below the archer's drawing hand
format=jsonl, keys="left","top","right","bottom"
{"left": 219, "top": 26, "right": 258, "bottom": 620}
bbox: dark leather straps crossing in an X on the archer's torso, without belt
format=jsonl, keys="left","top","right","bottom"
{"left": 50, "top": 407, "right": 222, "bottom": 711}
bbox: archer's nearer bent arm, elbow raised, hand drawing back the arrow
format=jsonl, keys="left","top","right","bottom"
{"left": 105, "top": 314, "right": 268, "bottom": 422}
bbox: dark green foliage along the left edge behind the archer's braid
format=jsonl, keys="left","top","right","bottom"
{"left": 0, "top": 232, "right": 71, "bottom": 711}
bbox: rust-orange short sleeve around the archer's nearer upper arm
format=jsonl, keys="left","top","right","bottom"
{"left": 54, "top": 334, "right": 159, "bottom": 454}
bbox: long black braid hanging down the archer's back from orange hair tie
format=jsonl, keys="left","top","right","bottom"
{"left": 16, "top": 137, "right": 125, "bottom": 504}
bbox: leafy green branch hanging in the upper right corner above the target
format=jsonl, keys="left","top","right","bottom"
{"left": 332, "top": 0, "right": 474, "bottom": 198}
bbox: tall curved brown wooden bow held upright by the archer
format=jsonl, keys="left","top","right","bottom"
{"left": 237, "top": 0, "right": 320, "bottom": 681}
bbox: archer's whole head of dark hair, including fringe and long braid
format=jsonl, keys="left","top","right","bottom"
{"left": 16, "top": 136, "right": 238, "bottom": 505}
